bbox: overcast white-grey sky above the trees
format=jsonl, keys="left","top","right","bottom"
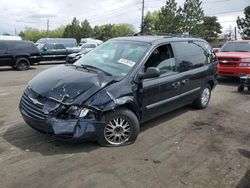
{"left": 0, "top": 0, "right": 250, "bottom": 34}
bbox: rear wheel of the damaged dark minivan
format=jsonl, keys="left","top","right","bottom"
{"left": 193, "top": 84, "right": 211, "bottom": 109}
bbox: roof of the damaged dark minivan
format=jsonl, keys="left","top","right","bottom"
{"left": 111, "top": 36, "right": 205, "bottom": 44}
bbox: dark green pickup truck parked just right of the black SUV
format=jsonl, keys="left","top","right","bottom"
{"left": 37, "top": 43, "right": 76, "bottom": 61}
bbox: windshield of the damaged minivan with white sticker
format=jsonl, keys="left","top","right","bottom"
{"left": 74, "top": 41, "right": 150, "bottom": 76}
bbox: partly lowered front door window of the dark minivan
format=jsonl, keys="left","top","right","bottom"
{"left": 145, "top": 44, "right": 177, "bottom": 74}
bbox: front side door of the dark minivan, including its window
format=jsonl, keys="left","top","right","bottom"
{"left": 141, "top": 44, "right": 182, "bottom": 121}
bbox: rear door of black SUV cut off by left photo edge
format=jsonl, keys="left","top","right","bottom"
{"left": 0, "top": 41, "right": 13, "bottom": 66}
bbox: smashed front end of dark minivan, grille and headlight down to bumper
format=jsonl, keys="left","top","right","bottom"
{"left": 19, "top": 88, "right": 104, "bottom": 139}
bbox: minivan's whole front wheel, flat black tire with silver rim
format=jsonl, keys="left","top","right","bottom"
{"left": 98, "top": 108, "right": 140, "bottom": 146}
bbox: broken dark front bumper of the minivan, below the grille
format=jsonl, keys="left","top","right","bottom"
{"left": 20, "top": 106, "right": 105, "bottom": 140}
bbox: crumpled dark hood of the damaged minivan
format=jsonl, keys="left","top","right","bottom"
{"left": 28, "top": 65, "right": 113, "bottom": 102}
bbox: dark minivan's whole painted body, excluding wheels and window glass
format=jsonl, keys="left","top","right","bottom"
{"left": 20, "top": 36, "right": 217, "bottom": 139}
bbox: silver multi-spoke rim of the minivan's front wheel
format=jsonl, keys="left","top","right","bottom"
{"left": 104, "top": 118, "right": 131, "bottom": 145}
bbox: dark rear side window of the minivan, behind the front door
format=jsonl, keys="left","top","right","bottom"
{"left": 173, "top": 41, "right": 207, "bottom": 72}
